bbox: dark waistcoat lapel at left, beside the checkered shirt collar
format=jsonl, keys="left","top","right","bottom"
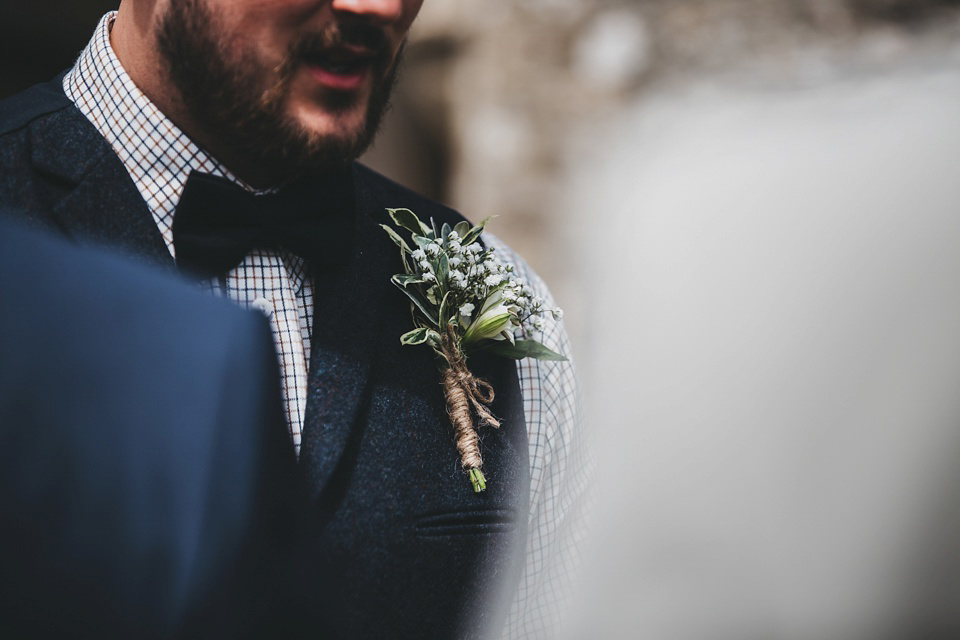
{"left": 28, "top": 92, "right": 174, "bottom": 268}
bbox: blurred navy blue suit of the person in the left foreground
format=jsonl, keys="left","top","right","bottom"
{"left": 0, "top": 215, "right": 296, "bottom": 638}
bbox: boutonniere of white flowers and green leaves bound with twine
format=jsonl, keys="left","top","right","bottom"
{"left": 381, "top": 209, "right": 566, "bottom": 492}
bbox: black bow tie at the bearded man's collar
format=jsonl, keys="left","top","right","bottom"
{"left": 173, "top": 168, "right": 354, "bottom": 278}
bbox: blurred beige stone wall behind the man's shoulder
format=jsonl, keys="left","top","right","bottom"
{"left": 366, "top": 0, "right": 960, "bottom": 344}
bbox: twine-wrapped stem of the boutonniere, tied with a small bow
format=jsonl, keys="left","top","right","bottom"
{"left": 441, "top": 325, "right": 500, "bottom": 493}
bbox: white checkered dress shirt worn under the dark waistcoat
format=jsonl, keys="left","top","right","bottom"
{"left": 63, "top": 13, "right": 588, "bottom": 638}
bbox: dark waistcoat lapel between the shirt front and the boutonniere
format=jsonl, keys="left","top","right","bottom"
{"left": 300, "top": 166, "right": 399, "bottom": 498}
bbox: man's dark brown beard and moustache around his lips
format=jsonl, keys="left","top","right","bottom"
{"left": 157, "top": 0, "right": 403, "bottom": 173}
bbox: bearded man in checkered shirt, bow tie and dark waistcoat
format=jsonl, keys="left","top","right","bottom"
{"left": 0, "top": 0, "right": 583, "bottom": 638}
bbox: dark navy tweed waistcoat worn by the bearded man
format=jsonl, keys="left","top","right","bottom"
{"left": 0, "top": 79, "right": 529, "bottom": 638}
